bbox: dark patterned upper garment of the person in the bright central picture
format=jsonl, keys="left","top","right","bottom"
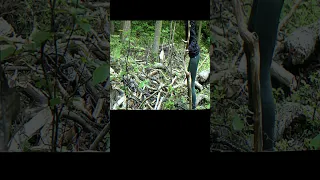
{"left": 185, "top": 21, "right": 200, "bottom": 58}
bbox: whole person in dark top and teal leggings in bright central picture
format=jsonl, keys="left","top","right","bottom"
{"left": 185, "top": 21, "right": 200, "bottom": 110}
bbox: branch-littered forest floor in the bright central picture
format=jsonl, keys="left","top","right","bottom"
{"left": 110, "top": 35, "right": 210, "bottom": 110}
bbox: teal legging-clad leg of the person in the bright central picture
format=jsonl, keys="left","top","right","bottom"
{"left": 188, "top": 54, "right": 200, "bottom": 109}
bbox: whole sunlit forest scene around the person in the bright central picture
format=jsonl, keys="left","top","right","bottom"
{"left": 110, "top": 20, "right": 210, "bottom": 110}
